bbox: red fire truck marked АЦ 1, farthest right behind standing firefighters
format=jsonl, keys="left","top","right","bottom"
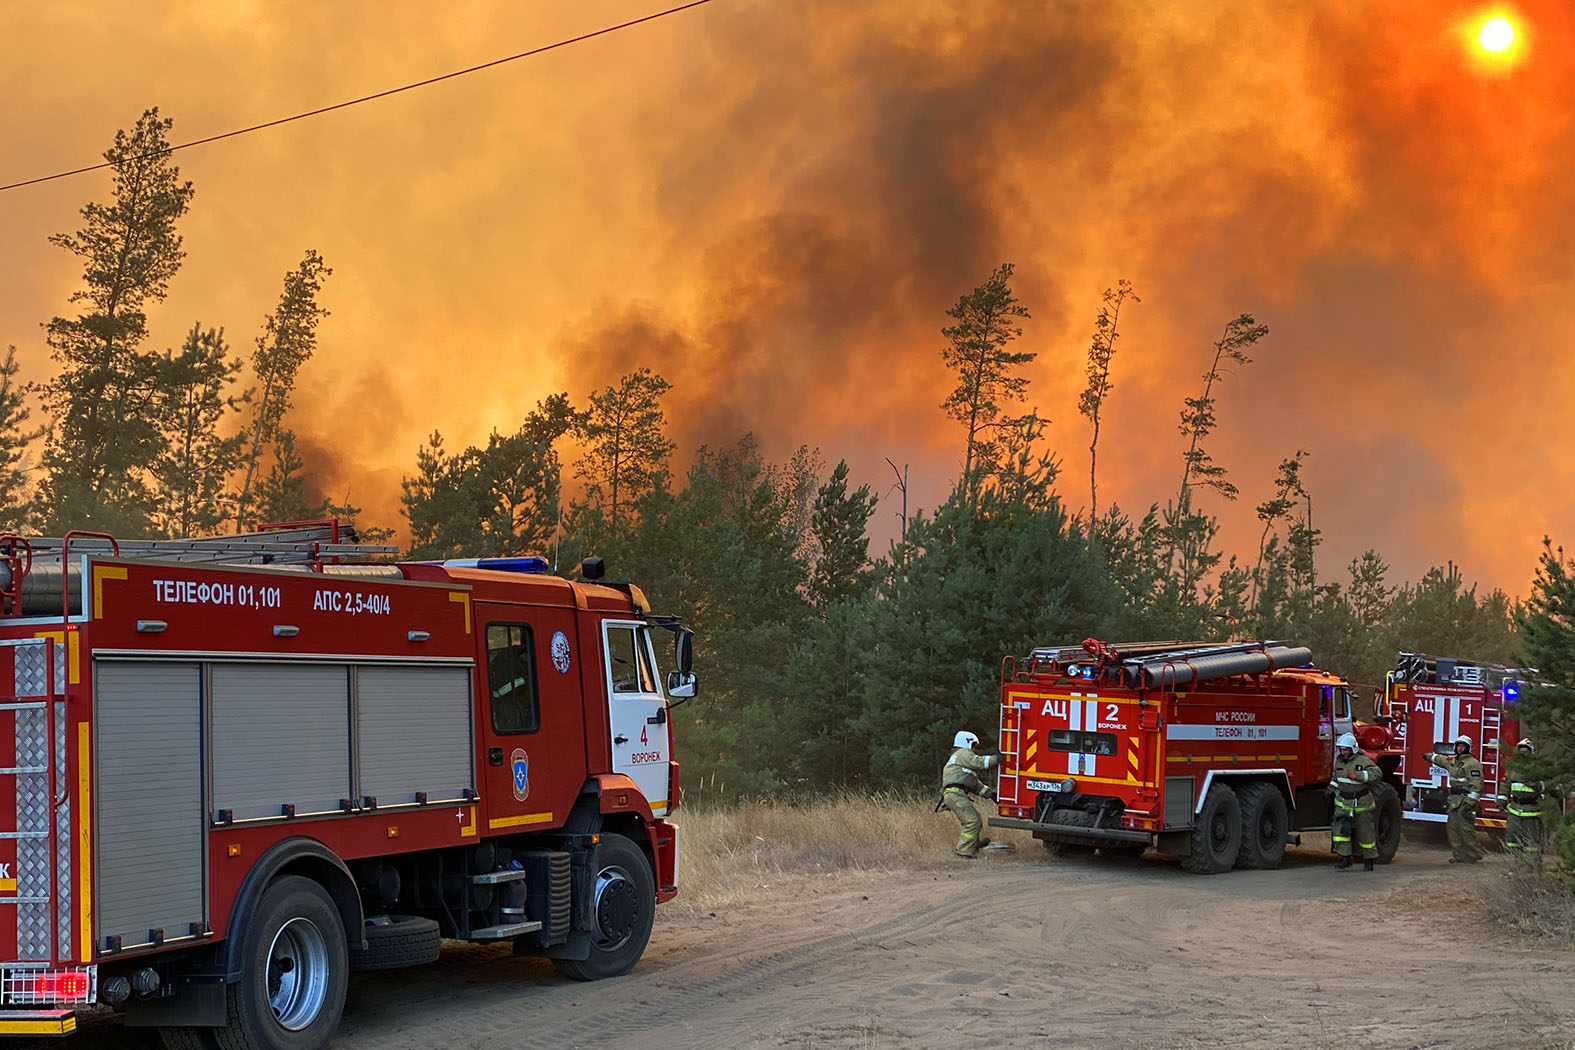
{"left": 1378, "top": 653, "right": 1532, "bottom": 831}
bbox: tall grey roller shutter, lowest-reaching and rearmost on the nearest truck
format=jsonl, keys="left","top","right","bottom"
{"left": 93, "top": 661, "right": 206, "bottom": 949}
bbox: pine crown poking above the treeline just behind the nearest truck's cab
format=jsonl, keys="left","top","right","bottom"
{"left": 575, "top": 368, "right": 676, "bottom": 537}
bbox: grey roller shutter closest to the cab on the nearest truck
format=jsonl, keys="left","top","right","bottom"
{"left": 356, "top": 666, "right": 476, "bottom": 804}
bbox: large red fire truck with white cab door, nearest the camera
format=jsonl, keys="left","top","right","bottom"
{"left": 0, "top": 523, "right": 695, "bottom": 1050}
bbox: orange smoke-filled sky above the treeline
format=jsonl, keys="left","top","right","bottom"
{"left": 0, "top": 0, "right": 1575, "bottom": 592}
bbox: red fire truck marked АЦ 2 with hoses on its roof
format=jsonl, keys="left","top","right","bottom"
{"left": 991, "top": 639, "right": 1400, "bottom": 874}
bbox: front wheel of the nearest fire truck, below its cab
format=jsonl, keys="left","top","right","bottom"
{"left": 553, "top": 833, "right": 657, "bottom": 981}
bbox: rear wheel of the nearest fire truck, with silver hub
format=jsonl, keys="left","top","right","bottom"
{"left": 214, "top": 875, "right": 350, "bottom": 1050}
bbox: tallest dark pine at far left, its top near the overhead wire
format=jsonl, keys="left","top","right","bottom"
{"left": 39, "top": 109, "right": 192, "bottom": 535}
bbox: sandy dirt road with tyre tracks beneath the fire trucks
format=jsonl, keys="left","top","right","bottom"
{"left": 55, "top": 847, "right": 1575, "bottom": 1050}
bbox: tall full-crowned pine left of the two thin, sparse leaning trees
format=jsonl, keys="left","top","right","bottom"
{"left": 940, "top": 263, "right": 1038, "bottom": 502}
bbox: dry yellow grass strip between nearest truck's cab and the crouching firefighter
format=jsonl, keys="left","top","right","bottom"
{"left": 669, "top": 792, "right": 1044, "bottom": 911}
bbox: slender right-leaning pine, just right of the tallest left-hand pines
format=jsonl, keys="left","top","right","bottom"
{"left": 236, "top": 250, "right": 334, "bottom": 532}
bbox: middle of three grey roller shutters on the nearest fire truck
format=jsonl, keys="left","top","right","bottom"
{"left": 209, "top": 664, "right": 350, "bottom": 820}
